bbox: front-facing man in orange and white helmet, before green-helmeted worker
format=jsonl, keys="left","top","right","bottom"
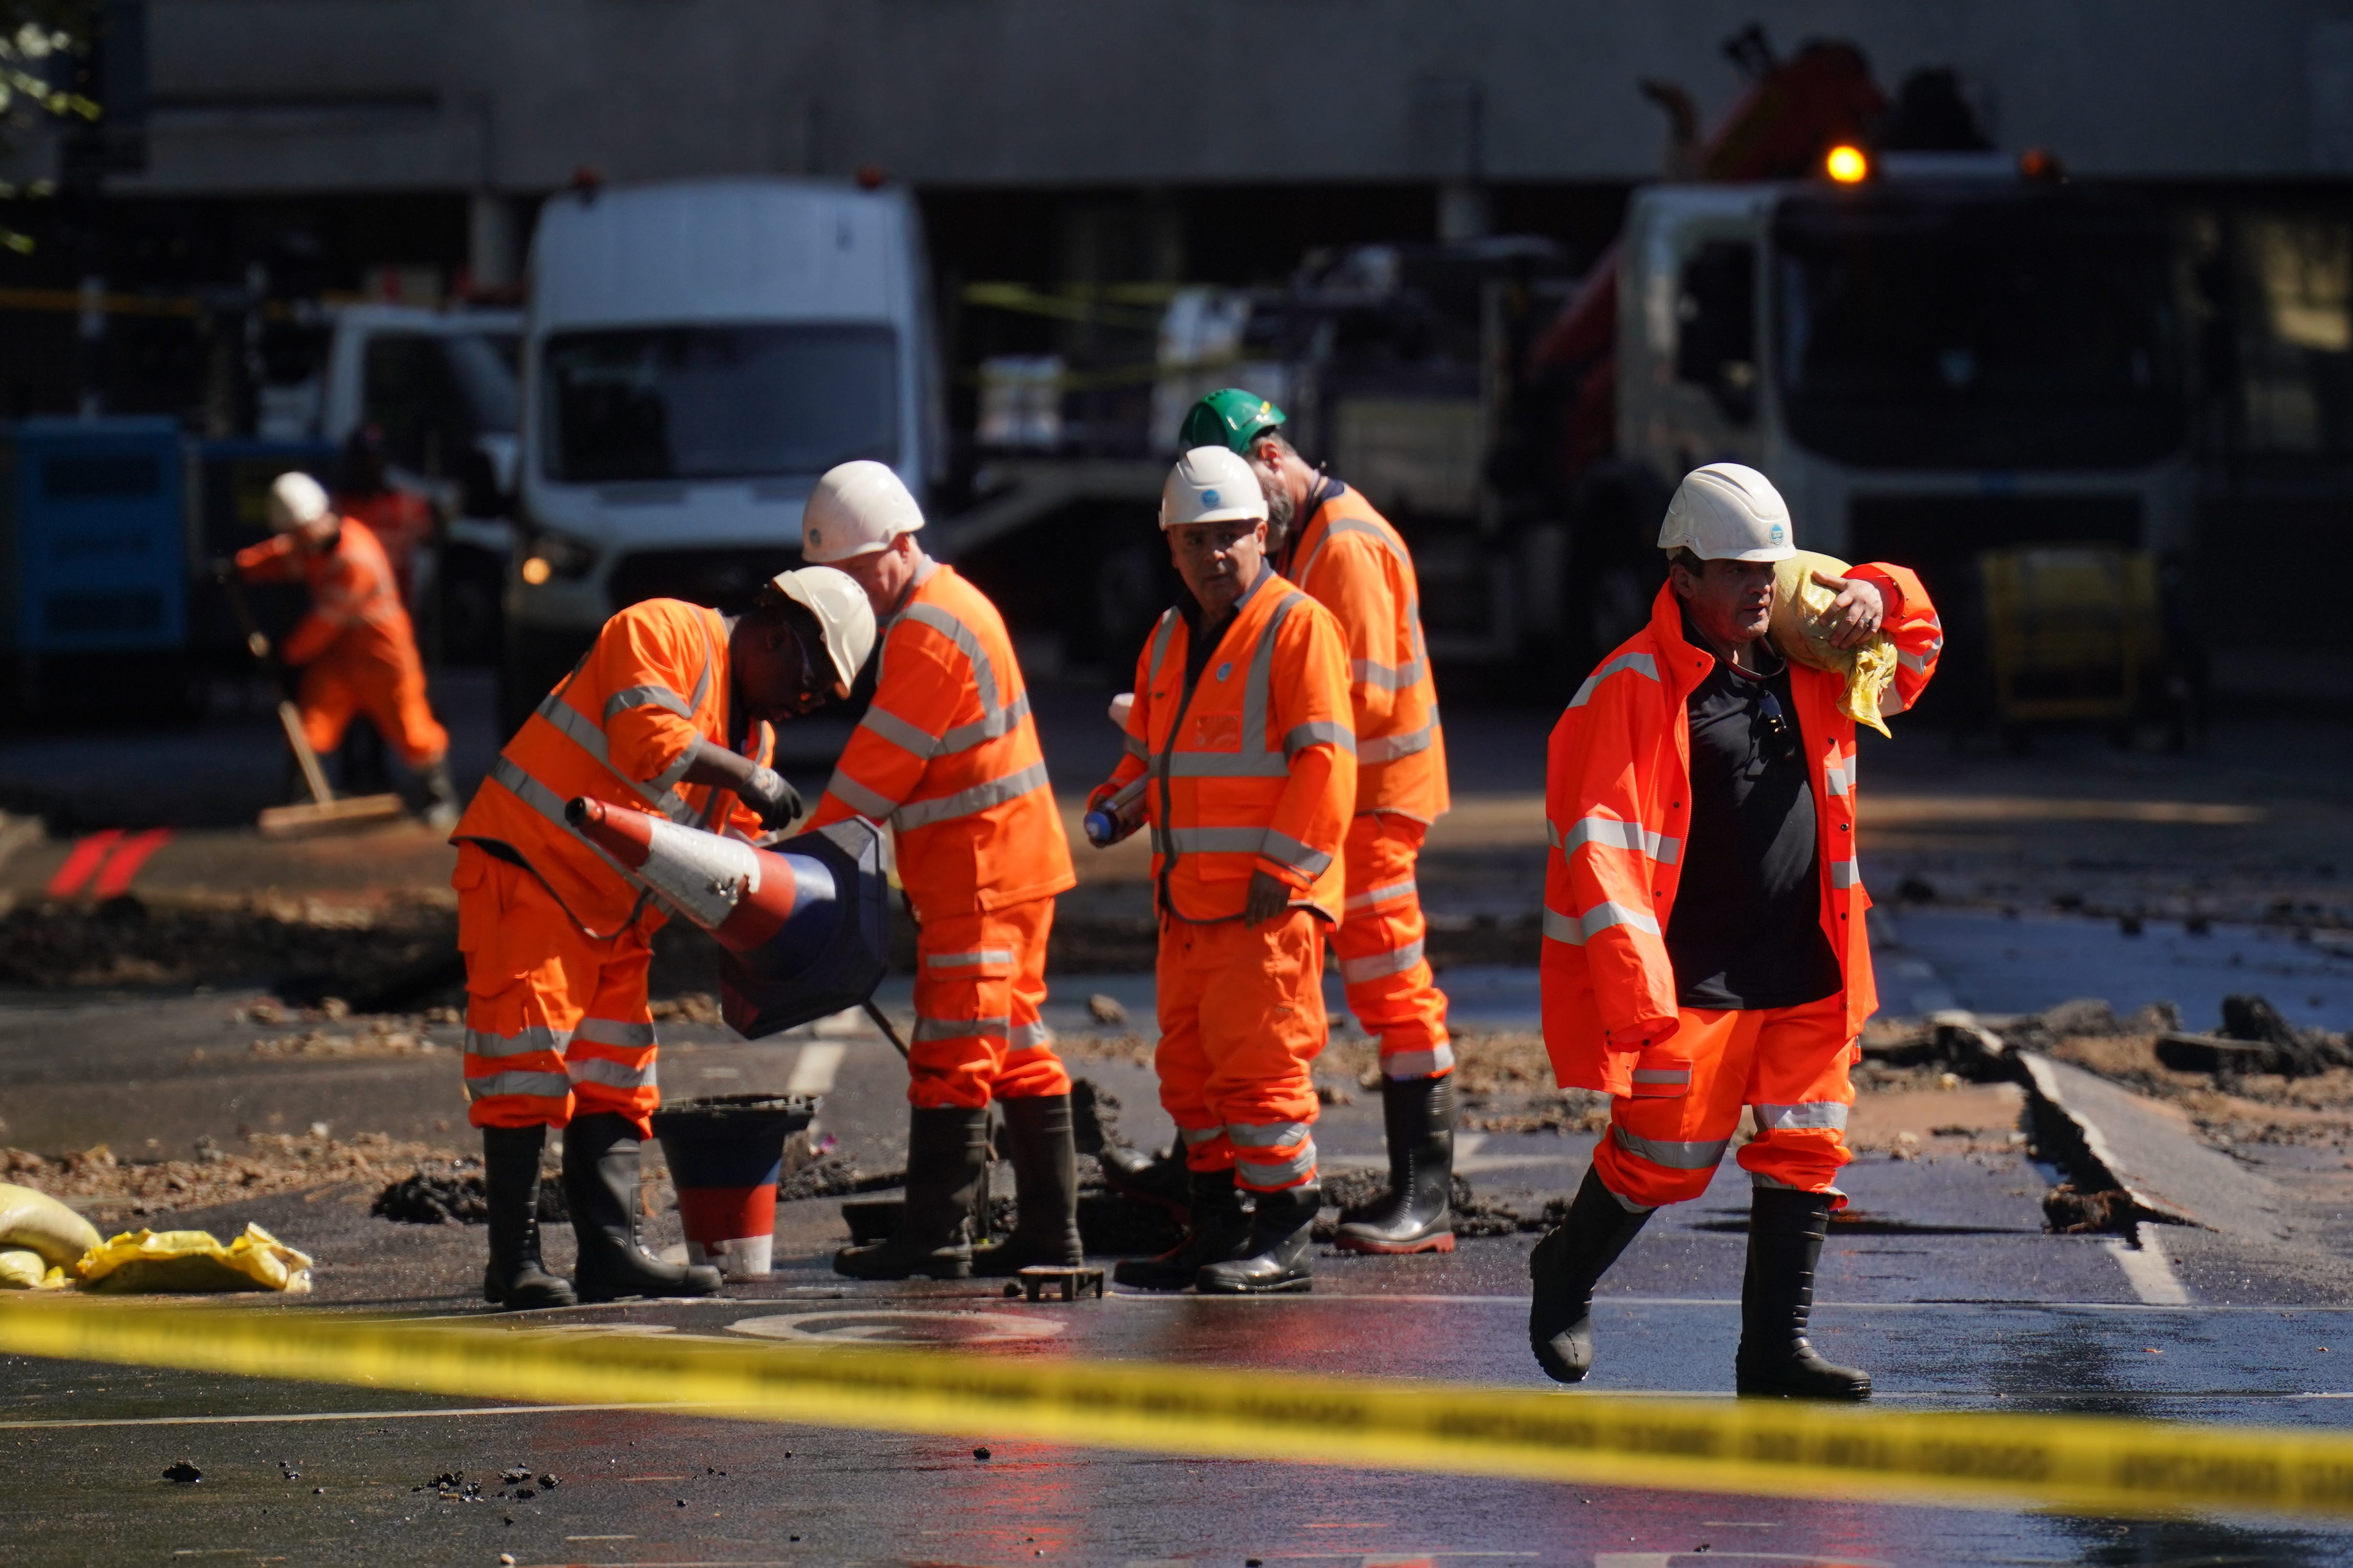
{"left": 1087, "top": 447, "right": 1355, "bottom": 1295}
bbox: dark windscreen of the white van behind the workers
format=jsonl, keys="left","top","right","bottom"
{"left": 541, "top": 322, "right": 899, "bottom": 484}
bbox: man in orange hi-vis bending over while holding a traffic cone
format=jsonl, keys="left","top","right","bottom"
{"left": 452, "top": 566, "right": 873, "bottom": 1307}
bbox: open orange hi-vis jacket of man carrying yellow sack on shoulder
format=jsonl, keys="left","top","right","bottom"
{"left": 1541, "top": 564, "right": 1944, "bottom": 1095}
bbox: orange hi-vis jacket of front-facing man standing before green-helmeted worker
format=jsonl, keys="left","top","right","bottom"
{"left": 1090, "top": 566, "right": 1355, "bottom": 924}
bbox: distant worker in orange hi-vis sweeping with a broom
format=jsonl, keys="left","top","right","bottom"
{"left": 237, "top": 473, "right": 456, "bottom": 828}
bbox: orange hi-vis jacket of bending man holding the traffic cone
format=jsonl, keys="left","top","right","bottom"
{"left": 449, "top": 600, "right": 760, "bottom": 938}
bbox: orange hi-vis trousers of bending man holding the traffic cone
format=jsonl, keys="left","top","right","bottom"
{"left": 454, "top": 844, "right": 661, "bottom": 1138}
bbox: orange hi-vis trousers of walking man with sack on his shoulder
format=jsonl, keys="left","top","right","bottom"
{"left": 1593, "top": 992, "right": 1859, "bottom": 1208}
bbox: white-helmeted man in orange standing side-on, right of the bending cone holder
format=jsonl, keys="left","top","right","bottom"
{"left": 800, "top": 461, "right": 1082, "bottom": 1279}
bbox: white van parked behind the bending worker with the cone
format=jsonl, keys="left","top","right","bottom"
{"left": 499, "top": 179, "right": 944, "bottom": 729}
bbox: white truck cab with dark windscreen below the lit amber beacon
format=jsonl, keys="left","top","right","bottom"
{"left": 1602, "top": 175, "right": 2193, "bottom": 630}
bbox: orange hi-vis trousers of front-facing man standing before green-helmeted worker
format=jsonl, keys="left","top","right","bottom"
{"left": 1153, "top": 910, "right": 1325, "bottom": 1192}
